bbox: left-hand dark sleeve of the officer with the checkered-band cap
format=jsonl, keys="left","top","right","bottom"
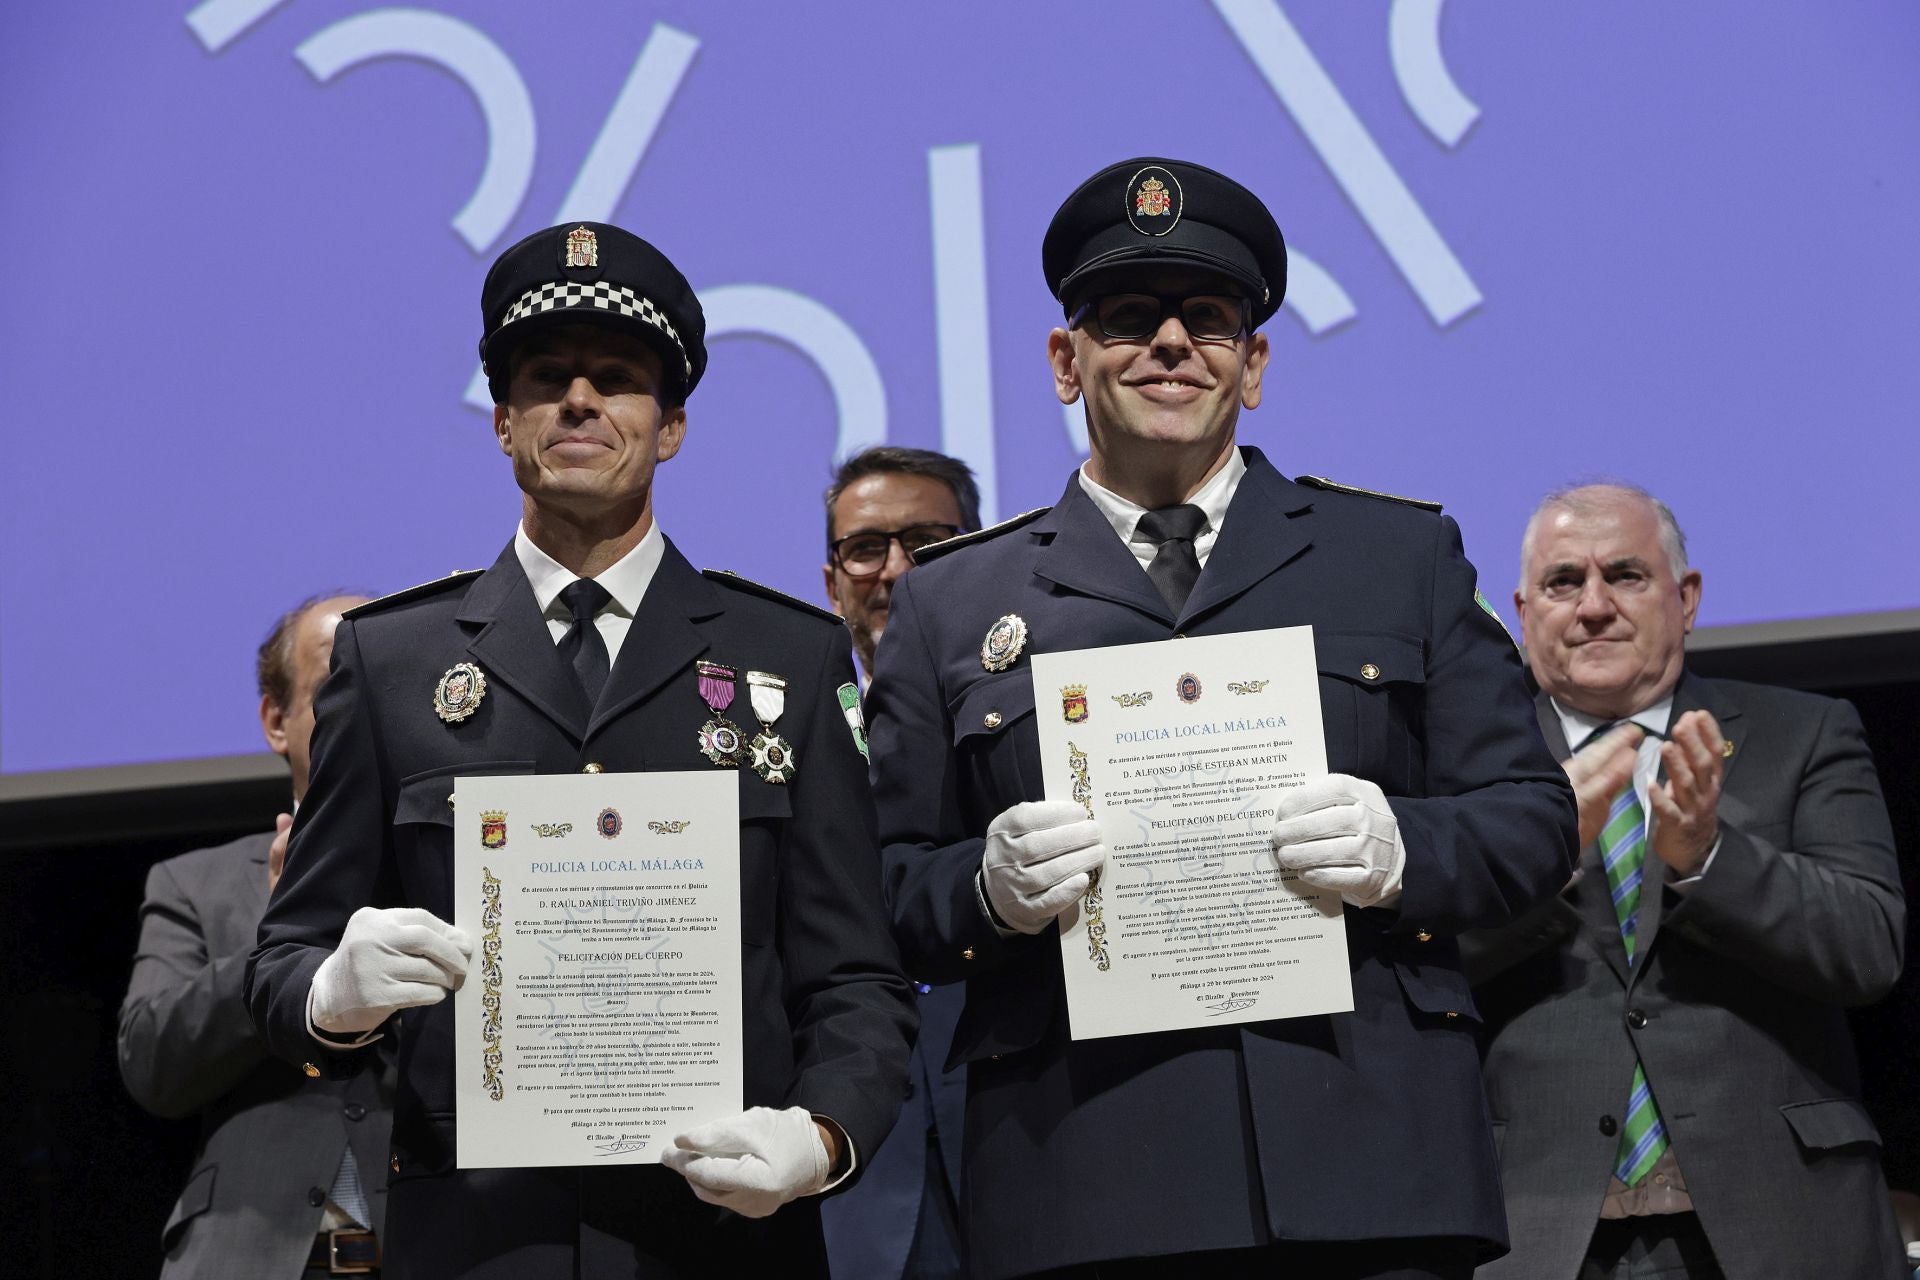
{"left": 246, "top": 620, "right": 396, "bottom": 1077}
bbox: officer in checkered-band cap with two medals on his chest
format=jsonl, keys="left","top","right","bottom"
{"left": 248, "top": 223, "right": 914, "bottom": 1280}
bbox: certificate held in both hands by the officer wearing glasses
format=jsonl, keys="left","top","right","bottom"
{"left": 1033, "top": 628, "right": 1354, "bottom": 1040}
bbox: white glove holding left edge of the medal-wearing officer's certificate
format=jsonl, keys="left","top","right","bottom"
{"left": 307, "top": 906, "right": 474, "bottom": 1036}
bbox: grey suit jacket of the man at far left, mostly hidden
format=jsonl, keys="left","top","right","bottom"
{"left": 119, "top": 833, "right": 392, "bottom": 1280}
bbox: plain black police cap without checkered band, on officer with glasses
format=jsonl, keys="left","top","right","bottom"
{"left": 1041, "top": 155, "right": 1286, "bottom": 328}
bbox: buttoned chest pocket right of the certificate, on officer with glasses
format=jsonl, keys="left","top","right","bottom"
{"left": 1313, "top": 631, "right": 1427, "bottom": 796}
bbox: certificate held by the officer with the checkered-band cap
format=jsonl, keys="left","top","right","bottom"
{"left": 453, "top": 770, "right": 743, "bottom": 1169}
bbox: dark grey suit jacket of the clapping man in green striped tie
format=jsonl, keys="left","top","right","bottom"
{"left": 1467, "top": 676, "right": 1907, "bottom": 1280}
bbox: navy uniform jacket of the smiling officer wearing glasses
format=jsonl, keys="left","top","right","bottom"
{"left": 868, "top": 449, "right": 1578, "bottom": 1280}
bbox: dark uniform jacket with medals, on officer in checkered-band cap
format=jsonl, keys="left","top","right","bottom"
{"left": 248, "top": 543, "right": 914, "bottom": 1280}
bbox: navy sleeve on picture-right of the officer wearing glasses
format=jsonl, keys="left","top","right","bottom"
{"left": 1390, "top": 516, "right": 1580, "bottom": 935}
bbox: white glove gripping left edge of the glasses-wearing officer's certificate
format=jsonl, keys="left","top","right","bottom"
{"left": 979, "top": 800, "right": 1106, "bottom": 933}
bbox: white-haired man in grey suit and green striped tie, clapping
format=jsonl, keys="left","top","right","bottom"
{"left": 1463, "top": 486, "right": 1905, "bottom": 1280}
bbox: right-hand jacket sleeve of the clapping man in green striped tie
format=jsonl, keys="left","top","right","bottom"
{"left": 1661, "top": 700, "right": 1907, "bottom": 1006}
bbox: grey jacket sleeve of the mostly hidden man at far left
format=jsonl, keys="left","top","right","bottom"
{"left": 119, "top": 864, "right": 267, "bottom": 1119}
